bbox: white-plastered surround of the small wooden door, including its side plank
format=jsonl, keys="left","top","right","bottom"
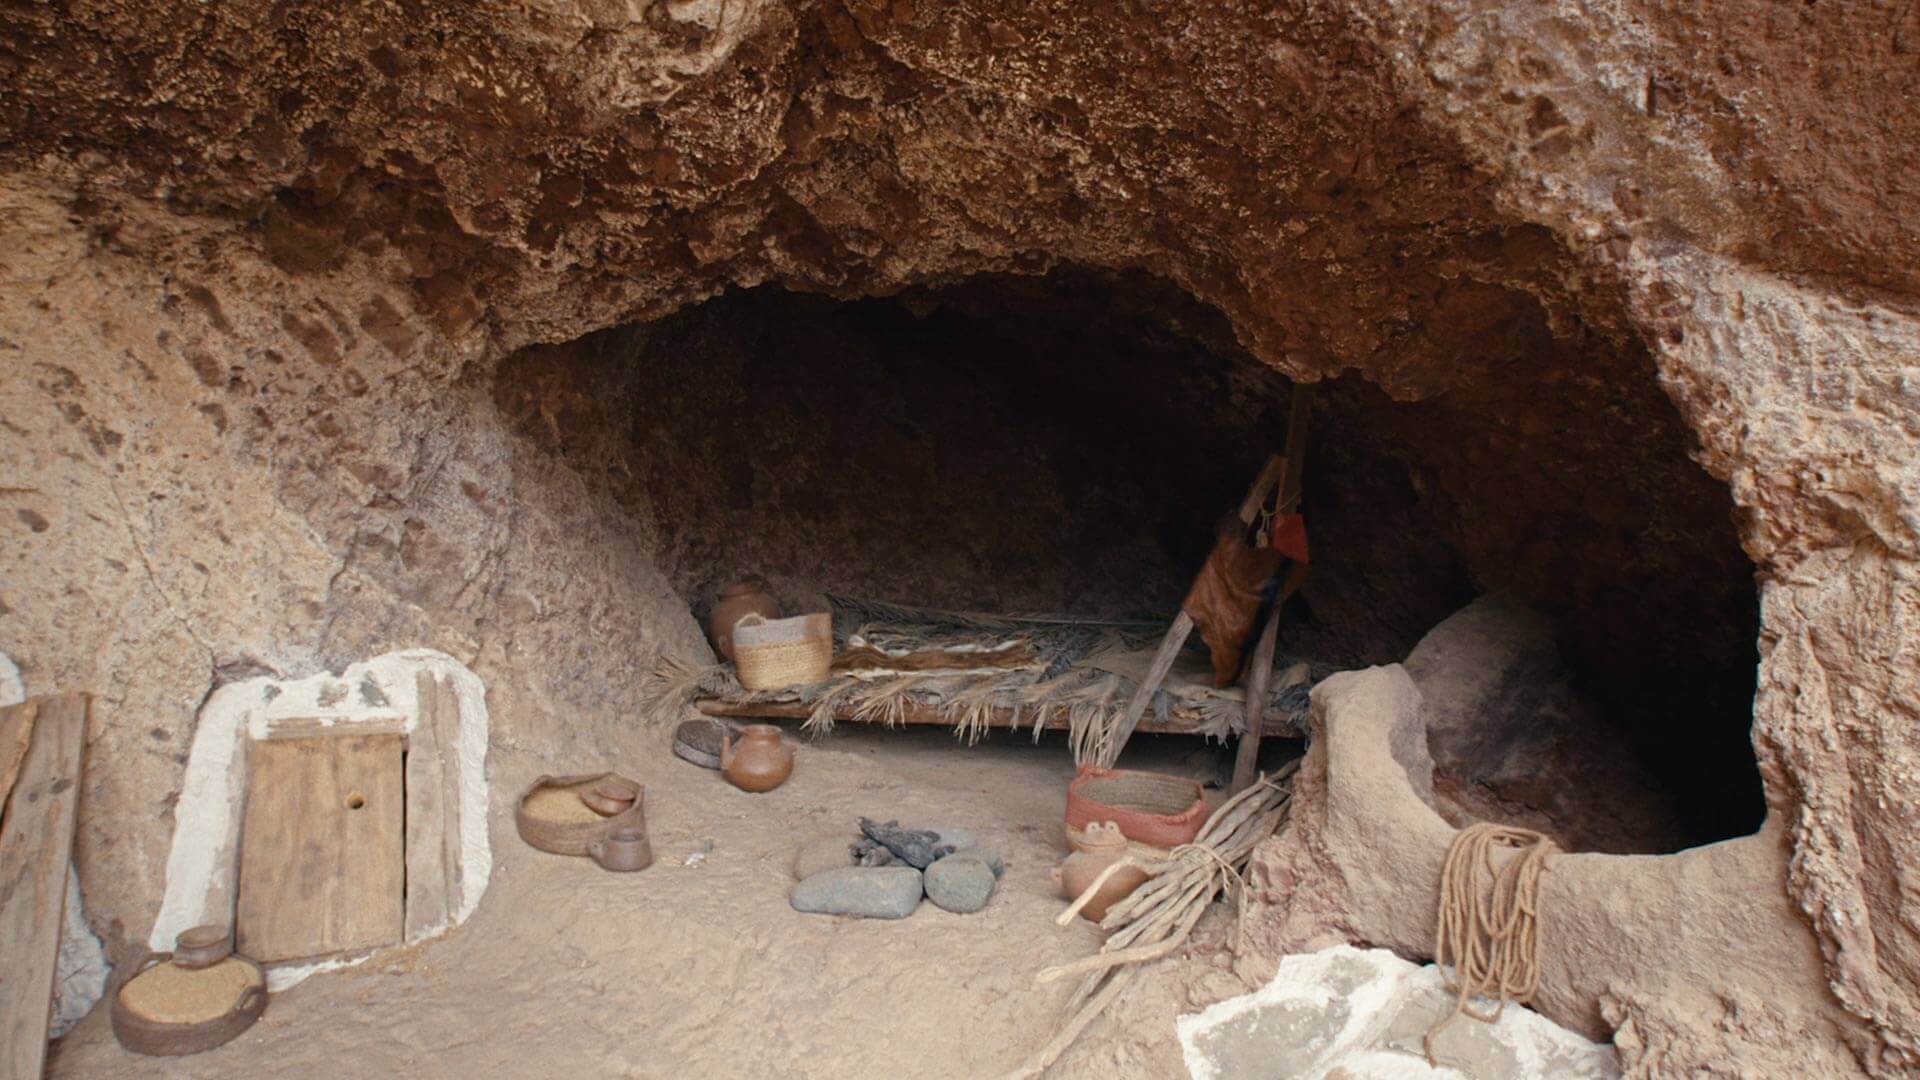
{"left": 148, "top": 650, "right": 493, "bottom": 990}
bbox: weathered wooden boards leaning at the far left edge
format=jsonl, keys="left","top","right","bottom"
{"left": 0, "top": 694, "right": 88, "bottom": 1078}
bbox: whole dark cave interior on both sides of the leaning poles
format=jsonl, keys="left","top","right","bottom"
{"left": 493, "top": 271, "right": 1763, "bottom": 851}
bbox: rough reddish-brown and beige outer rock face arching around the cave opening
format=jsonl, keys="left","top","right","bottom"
{"left": 0, "top": 0, "right": 1920, "bottom": 1072}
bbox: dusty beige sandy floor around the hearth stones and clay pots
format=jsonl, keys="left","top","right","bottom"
{"left": 48, "top": 728, "right": 1297, "bottom": 1080}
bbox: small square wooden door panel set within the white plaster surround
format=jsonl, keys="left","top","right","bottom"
{"left": 234, "top": 734, "right": 407, "bottom": 963}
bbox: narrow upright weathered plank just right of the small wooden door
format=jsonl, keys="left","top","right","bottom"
{"left": 407, "top": 671, "right": 461, "bottom": 940}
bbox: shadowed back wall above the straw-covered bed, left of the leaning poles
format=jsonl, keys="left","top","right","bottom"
{"left": 493, "top": 273, "right": 1288, "bottom": 621}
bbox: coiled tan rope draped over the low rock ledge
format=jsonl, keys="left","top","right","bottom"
{"left": 1425, "top": 821, "right": 1559, "bottom": 1068}
